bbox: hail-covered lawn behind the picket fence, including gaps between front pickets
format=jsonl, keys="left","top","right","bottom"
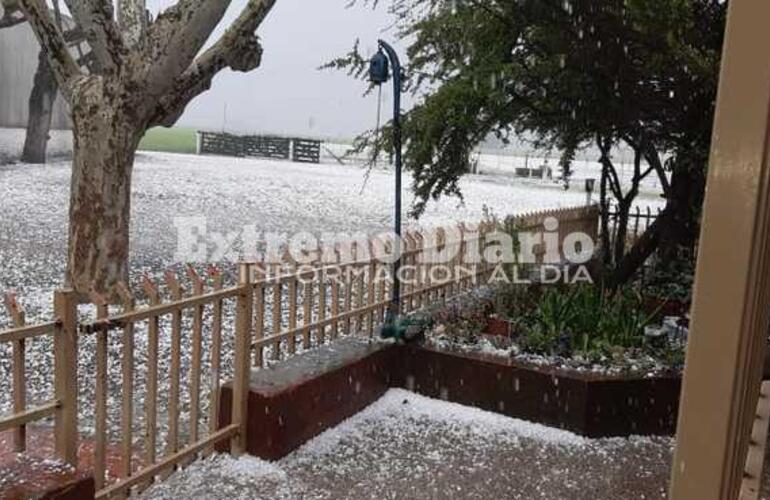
{"left": 0, "top": 149, "right": 660, "bottom": 446}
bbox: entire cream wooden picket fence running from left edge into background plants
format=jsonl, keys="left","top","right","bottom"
{"left": 0, "top": 203, "right": 598, "bottom": 498}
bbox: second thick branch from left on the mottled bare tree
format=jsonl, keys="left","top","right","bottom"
{"left": 64, "top": 0, "right": 125, "bottom": 71}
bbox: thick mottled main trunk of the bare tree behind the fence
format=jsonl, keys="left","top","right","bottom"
{"left": 67, "top": 79, "right": 145, "bottom": 297}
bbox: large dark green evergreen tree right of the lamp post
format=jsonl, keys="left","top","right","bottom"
{"left": 328, "top": 0, "right": 727, "bottom": 284}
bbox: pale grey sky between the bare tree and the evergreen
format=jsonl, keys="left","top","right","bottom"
{"left": 148, "top": 0, "right": 409, "bottom": 138}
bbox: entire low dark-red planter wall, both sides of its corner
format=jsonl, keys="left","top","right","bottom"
{"left": 220, "top": 344, "right": 680, "bottom": 460}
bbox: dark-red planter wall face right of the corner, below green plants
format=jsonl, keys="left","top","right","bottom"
{"left": 400, "top": 346, "right": 681, "bottom": 437}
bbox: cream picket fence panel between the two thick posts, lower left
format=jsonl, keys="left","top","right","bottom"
{"left": 80, "top": 267, "right": 253, "bottom": 498}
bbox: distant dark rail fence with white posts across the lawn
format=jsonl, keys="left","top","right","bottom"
{"left": 196, "top": 131, "right": 321, "bottom": 163}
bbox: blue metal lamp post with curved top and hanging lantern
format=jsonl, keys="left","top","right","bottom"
{"left": 369, "top": 40, "right": 401, "bottom": 324}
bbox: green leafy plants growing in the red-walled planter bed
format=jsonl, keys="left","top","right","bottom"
{"left": 428, "top": 284, "right": 684, "bottom": 369}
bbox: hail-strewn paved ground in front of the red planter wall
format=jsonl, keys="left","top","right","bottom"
{"left": 142, "top": 389, "right": 673, "bottom": 500}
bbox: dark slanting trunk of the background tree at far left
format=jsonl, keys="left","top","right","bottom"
{"left": 21, "top": 50, "right": 59, "bottom": 163}
